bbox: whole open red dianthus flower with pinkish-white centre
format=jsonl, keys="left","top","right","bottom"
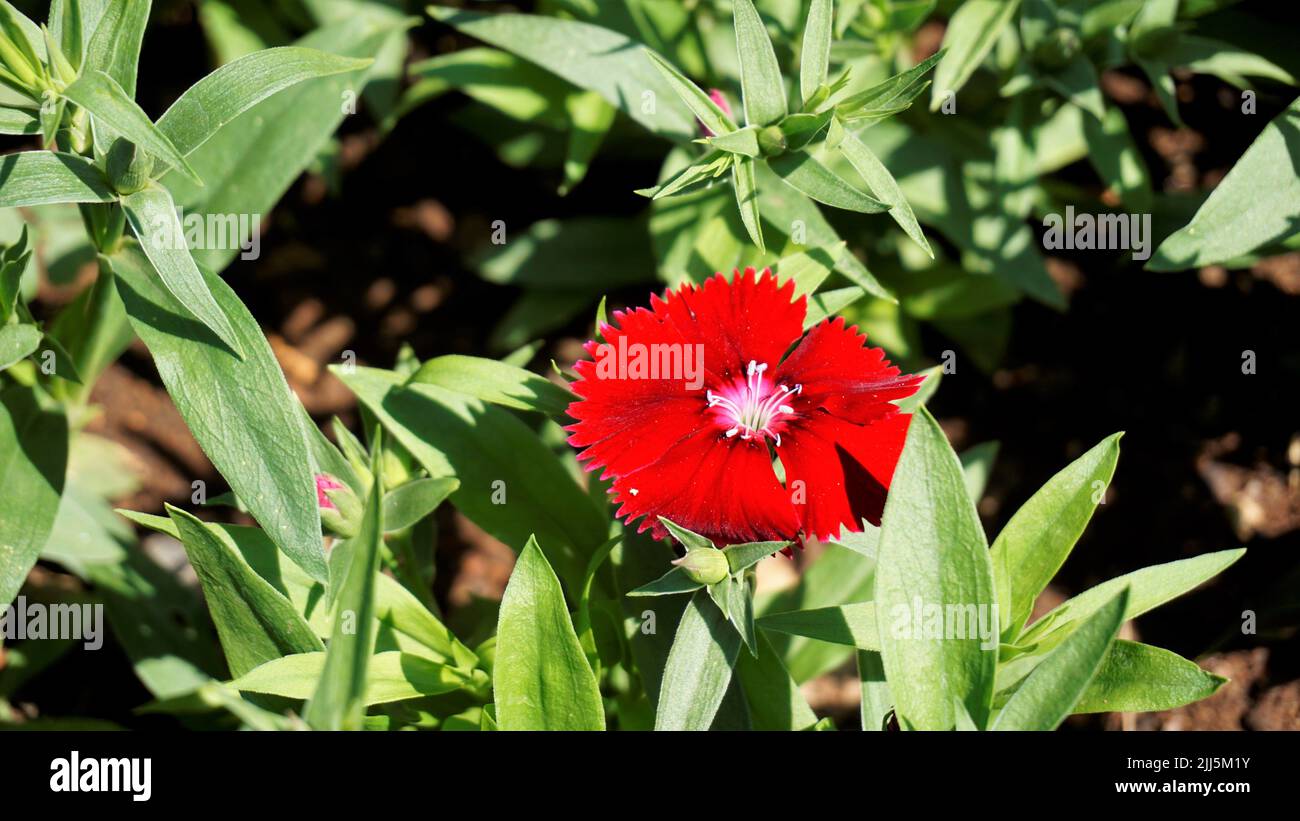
{"left": 567, "top": 268, "right": 923, "bottom": 546}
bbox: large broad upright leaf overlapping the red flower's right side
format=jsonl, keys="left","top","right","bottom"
{"left": 875, "top": 408, "right": 998, "bottom": 730}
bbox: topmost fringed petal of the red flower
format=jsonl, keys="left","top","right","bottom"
{"left": 650, "top": 268, "right": 807, "bottom": 383}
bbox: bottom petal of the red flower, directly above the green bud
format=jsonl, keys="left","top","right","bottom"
{"left": 614, "top": 427, "right": 800, "bottom": 547}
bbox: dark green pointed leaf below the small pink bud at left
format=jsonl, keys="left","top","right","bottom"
{"left": 166, "top": 505, "right": 325, "bottom": 678}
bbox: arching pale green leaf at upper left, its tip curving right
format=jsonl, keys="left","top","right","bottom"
{"left": 157, "top": 45, "right": 373, "bottom": 156}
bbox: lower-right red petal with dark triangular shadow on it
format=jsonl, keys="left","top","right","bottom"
{"left": 776, "top": 411, "right": 911, "bottom": 540}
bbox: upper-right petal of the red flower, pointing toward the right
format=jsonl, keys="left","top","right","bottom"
{"left": 776, "top": 317, "right": 924, "bottom": 425}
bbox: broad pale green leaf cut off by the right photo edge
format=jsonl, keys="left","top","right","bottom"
{"left": 1147, "top": 100, "right": 1300, "bottom": 270}
